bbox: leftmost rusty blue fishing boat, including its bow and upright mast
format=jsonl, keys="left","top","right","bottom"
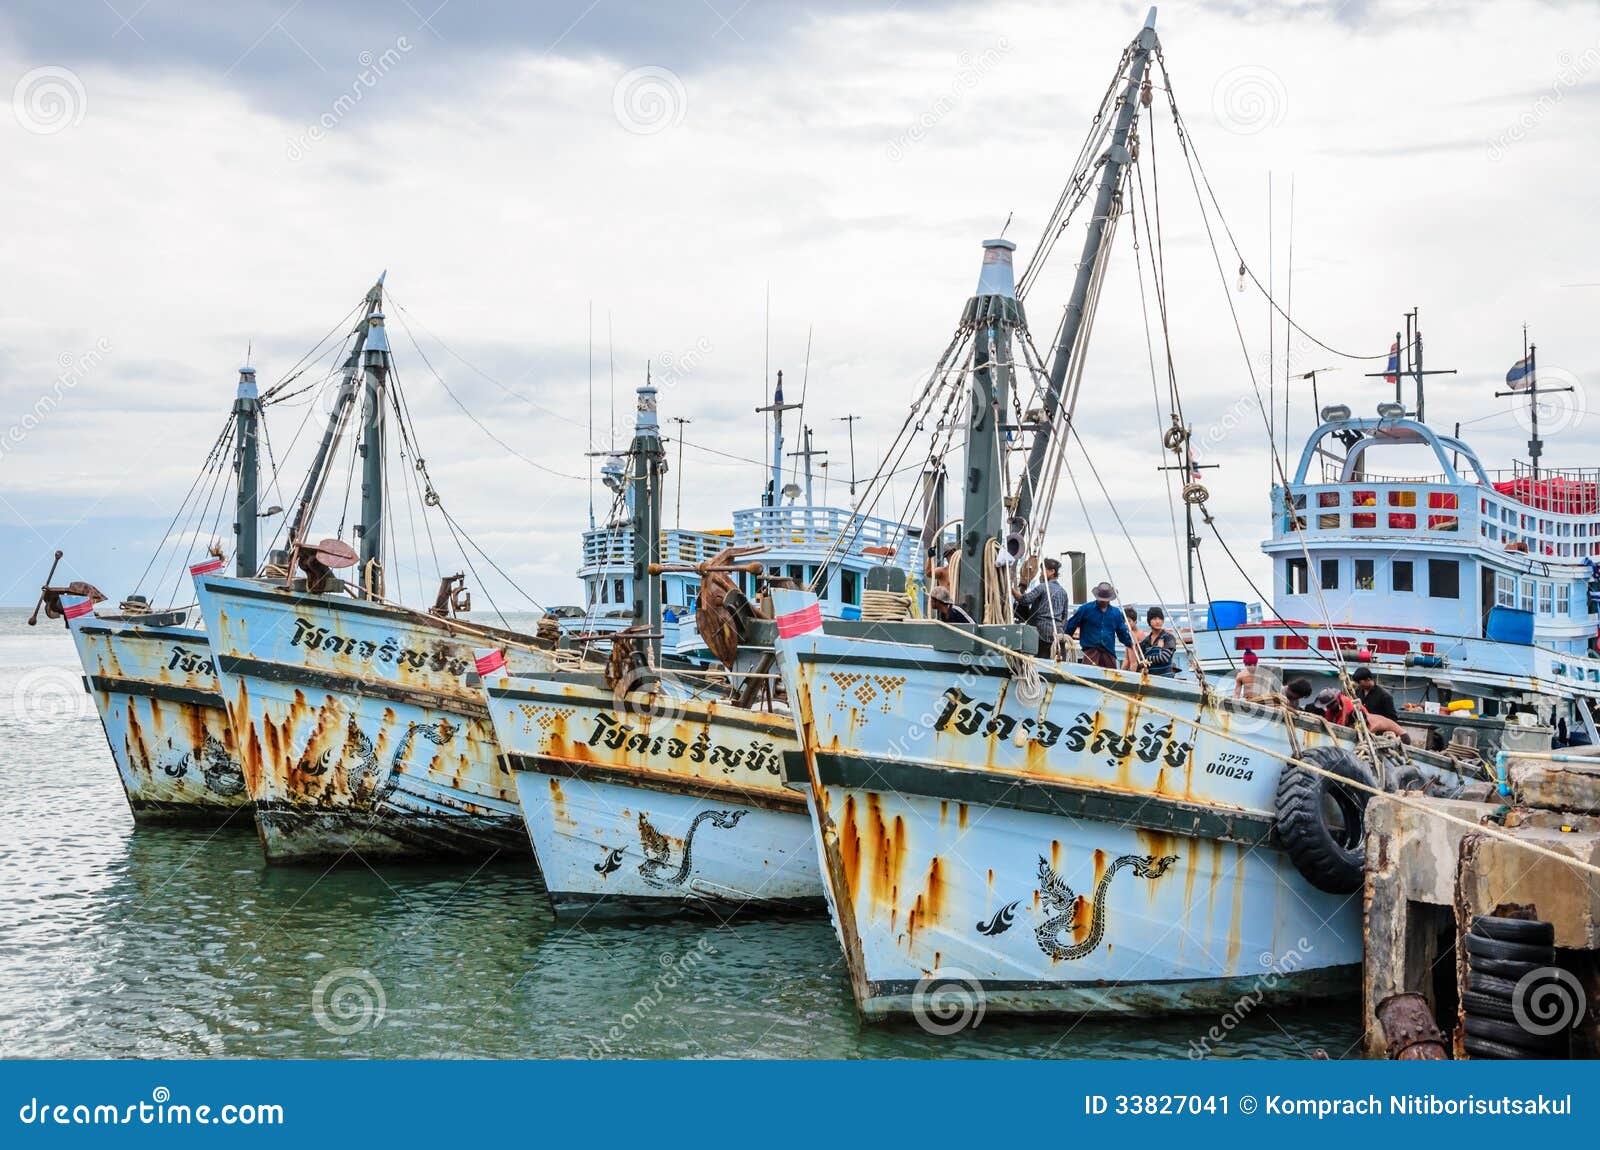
{"left": 44, "top": 366, "right": 262, "bottom": 825}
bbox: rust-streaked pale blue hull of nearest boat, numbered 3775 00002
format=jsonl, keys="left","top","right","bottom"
{"left": 779, "top": 608, "right": 1362, "bottom": 1017}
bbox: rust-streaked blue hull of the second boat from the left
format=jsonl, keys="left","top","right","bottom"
{"left": 195, "top": 576, "right": 544, "bottom": 862}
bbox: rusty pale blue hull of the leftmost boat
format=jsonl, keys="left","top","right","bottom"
{"left": 67, "top": 613, "right": 250, "bottom": 825}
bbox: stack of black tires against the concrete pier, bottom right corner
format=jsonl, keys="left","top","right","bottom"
{"left": 1461, "top": 915, "right": 1566, "bottom": 1059}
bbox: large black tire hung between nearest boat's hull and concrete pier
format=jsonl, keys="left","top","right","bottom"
{"left": 1275, "top": 747, "right": 1376, "bottom": 894}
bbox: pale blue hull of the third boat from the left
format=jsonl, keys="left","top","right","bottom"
{"left": 485, "top": 675, "right": 822, "bottom": 915}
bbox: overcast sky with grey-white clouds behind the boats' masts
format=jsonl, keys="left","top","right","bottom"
{"left": 0, "top": 0, "right": 1600, "bottom": 608}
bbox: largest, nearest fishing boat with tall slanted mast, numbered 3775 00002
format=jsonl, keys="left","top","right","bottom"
{"left": 774, "top": 10, "right": 1454, "bottom": 1019}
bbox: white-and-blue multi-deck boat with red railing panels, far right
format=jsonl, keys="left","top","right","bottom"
{"left": 1195, "top": 353, "right": 1600, "bottom": 765}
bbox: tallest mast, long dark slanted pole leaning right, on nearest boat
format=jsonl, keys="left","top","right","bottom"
{"left": 1017, "top": 8, "right": 1157, "bottom": 524}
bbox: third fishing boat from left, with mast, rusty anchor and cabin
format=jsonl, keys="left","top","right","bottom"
{"left": 478, "top": 382, "right": 917, "bottom": 915}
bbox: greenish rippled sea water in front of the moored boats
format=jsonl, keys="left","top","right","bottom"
{"left": 0, "top": 611, "right": 1360, "bottom": 1059}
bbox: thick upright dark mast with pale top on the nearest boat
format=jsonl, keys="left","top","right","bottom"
{"left": 955, "top": 240, "right": 1022, "bottom": 622}
